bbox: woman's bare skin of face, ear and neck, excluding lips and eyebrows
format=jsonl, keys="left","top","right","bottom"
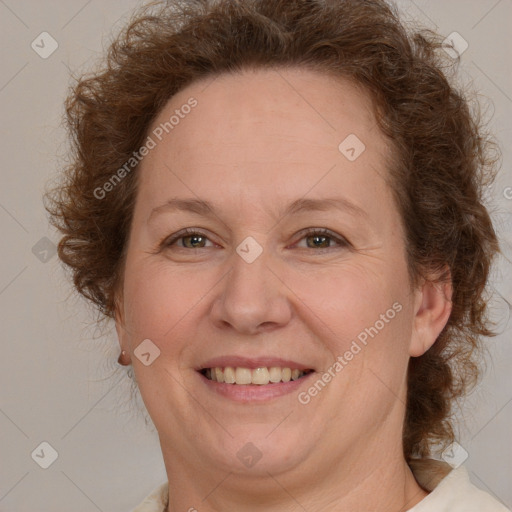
{"left": 116, "top": 68, "right": 451, "bottom": 512}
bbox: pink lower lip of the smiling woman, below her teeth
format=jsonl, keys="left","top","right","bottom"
{"left": 198, "top": 372, "right": 315, "bottom": 402}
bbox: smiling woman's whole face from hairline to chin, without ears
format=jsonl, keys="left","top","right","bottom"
{"left": 117, "top": 69, "right": 432, "bottom": 481}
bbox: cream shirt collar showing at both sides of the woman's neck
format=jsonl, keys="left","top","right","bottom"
{"left": 132, "top": 459, "right": 511, "bottom": 512}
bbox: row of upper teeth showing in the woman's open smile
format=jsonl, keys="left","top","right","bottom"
{"left": 204, "top": 366, "right": 308, "bottom": 385}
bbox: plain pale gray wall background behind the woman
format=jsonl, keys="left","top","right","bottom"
{"left": 0, "top": 0, "right": 512, "bottom": 512}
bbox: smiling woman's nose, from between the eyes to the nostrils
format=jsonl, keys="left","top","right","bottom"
{"left": 210, "top": 244, "right": 292, "bottom": 334}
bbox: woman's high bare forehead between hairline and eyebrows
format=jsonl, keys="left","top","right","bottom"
{"left": 135, "top": 64, "right": 389, "bottom": 216}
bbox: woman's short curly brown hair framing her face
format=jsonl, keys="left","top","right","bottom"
{"left": 47, "top": 0, "right": 499, "bottom": 461}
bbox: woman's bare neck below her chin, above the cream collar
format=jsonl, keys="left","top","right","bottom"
{"left": 164, "top": 438, "right": 427, "bottom": 512}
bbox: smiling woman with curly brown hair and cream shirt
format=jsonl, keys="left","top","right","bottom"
{"left": 49, "top": 0, "right": 506, "bottom": 512}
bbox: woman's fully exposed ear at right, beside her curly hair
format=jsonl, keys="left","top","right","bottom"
{"left": 409, "top": 270, "right": 453, "bottom": 357}
